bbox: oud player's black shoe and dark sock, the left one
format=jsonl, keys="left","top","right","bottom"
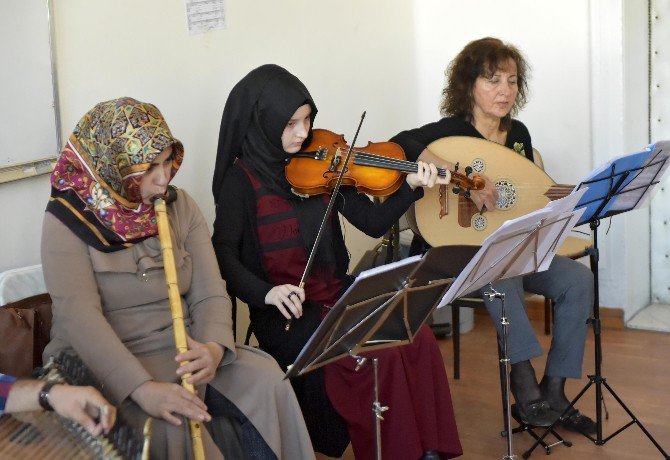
{"left": 510, "top": 360, "right": 556, "bottom": 426}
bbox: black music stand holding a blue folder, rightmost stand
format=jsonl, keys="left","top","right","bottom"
{"left": 528, "top": 141, "right": 670, "bottom": 459}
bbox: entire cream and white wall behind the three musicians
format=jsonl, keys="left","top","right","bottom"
{"left": 0, "top": 0, "right": 652, "bottom": 318}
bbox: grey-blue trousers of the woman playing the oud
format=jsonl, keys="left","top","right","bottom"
{"left": 481, "top": 256, "right": 594, "bottom": 378}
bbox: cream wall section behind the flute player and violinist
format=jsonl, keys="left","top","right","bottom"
{"left": 48, "top": 0, "right": 415, "bottom": 270}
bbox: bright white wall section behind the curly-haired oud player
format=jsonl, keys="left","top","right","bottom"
{"left": 415, "top": 0, "right": 591, "bottom": 183}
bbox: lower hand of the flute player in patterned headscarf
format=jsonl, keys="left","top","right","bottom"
{"left": 130, "top": 380, "right": 212, "bottom": 426}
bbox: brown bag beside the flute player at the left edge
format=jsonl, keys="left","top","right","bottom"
{"left": 0, "top": 294, "right": 51, "bottom": 377}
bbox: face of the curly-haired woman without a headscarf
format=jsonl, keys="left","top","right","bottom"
{"left": 472, "top": 59, "right": 519, "bottom": 119}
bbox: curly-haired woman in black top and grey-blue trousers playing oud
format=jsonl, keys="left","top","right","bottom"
{"left": 391, "top": 38, "right": 595, "bottom": 433}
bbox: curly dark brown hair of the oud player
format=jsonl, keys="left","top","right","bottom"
{"left": 440, "top": 37, "right": 530, "bottom": 129}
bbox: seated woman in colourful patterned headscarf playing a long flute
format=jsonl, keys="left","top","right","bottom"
{"left": 42, "top": 98, "right": 314, "bottom": 460}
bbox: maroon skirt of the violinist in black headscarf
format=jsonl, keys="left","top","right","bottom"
{"left": 325, "top": 326, "right": 463, "bottom": 460}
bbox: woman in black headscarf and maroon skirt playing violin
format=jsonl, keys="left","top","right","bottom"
{"left": 213, "top": 65, "right": 461, "bottom": 459}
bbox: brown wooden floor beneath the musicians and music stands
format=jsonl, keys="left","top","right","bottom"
{"left": 328, "top": 318, "right": 670, "bottom": 460}
